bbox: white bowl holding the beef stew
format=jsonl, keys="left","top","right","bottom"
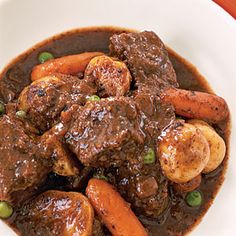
{"left": 0, "top": 0, "right": 236, "bottom": 236}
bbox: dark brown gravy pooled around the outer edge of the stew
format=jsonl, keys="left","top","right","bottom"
{"left": 0, "top": 27, "right": 230, "bottom": 235}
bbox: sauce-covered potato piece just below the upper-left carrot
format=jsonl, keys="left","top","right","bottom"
{"left": 18, "top": 74, "right": 97, "bottom": 131}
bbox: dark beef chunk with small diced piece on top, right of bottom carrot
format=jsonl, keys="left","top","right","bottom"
{"left": 110, "top": 148, "right": 169, "bottom": 218}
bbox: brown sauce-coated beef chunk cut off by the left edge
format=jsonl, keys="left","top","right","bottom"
{"left": 0, "top": 115, "right": 51, "bottom": 204}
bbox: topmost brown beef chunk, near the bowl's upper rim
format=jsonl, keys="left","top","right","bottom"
{"left": 109, "top": 31, "right": 178, "bottom": 93}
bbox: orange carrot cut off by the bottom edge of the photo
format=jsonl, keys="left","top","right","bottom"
{"left": 86, "top": 179, "right": 147, "bottom": 236}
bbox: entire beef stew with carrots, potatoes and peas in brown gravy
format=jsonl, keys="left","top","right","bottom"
{"left": 0, "top": 27, "right": 230, "bottom": 235}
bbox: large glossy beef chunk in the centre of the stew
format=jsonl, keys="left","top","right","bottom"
{"left": 65, "top": 97, "right": 145, "bottom": 167}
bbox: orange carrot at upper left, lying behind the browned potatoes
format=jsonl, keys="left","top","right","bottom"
{"left": 31, "top": 52, "right": 103, "bottom": 81}
